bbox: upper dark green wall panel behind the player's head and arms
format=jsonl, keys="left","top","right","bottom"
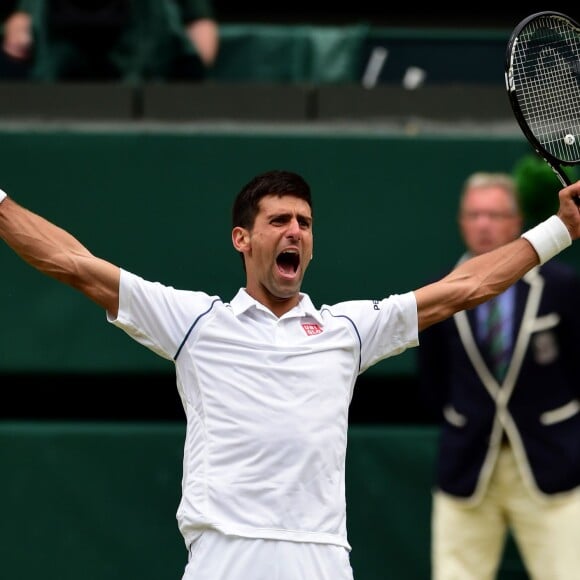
{"left": 0, "top": 124, "right": 578, "bottom": 375}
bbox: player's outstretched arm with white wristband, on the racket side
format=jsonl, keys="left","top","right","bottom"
{"left": 415, "top": 181, "right": 580, "bottom": 330}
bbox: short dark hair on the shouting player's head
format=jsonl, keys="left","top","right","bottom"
{"left": 232, "top": 169, "right": 312, "bottom": 229}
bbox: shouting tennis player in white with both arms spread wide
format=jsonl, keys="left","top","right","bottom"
{"left": 0, "top": 171, "right": 580, "bottom": 580}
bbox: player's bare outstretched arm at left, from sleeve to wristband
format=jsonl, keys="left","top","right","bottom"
{"left": 0, "top": 192, "right": 120, "bottom": 317}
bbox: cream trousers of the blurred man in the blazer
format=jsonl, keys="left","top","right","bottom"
{"left": 432, "top": 446, "right": 580, "bottom": 580}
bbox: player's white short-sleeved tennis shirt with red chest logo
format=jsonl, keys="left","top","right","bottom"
{"left": 109, "top": 270, "right": 418, "bottom": 549}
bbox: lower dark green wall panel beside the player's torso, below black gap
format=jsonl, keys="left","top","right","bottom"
{"left": 0, "top": 422, "right": 525, "bottom": 580}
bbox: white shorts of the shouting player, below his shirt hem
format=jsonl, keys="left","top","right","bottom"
{"left": 182, "top": 530, "right": 353, "bottom": 580}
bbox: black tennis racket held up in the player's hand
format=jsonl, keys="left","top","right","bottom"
{"left": 505, "top": 12, "right": 580, "bottom": 195}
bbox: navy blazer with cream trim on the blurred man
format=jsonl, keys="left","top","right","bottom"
{"left": 415, "top": 260, "right": 580, "bottom": 503}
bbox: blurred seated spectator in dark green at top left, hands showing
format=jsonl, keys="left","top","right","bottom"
{"left": 0, "top": 0, "right": 219, "bottom": 82}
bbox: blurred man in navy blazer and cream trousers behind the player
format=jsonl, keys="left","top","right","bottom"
{"left": 417, "top": 172, "right": 580, "bottom": 580}
